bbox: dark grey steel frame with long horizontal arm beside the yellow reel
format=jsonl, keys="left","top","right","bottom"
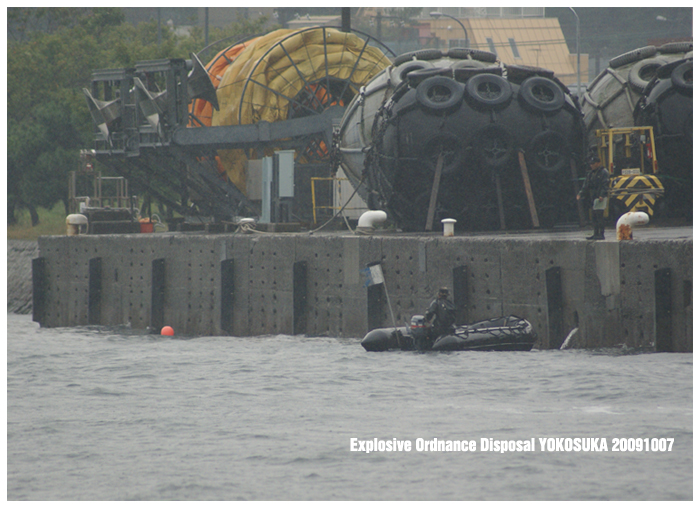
{"left": 84, "top": 27, "right": 395, "bottom": 219}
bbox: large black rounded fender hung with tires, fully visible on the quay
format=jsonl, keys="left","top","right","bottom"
{"left": 341, "top": 48, "right": 584, "bottom": 231}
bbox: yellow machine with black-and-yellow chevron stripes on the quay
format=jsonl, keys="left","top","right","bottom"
{"left": 596, "top": 127, "right": 664, "bottom": 218}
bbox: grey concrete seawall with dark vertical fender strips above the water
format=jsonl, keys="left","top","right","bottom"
{"left": 33, "top": 228, "right": 692, "bottom": 351}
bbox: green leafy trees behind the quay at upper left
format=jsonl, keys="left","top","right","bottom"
{"left": 7, "top": 8, "right": 266, "bottom": 226}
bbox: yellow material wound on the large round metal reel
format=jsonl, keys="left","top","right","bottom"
{"left": 209, "top": 27, "right": 391, "bottom": 192}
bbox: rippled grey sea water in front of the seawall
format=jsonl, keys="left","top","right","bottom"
{"left": 7, "top": 315, "right": 693, "bottom": 500}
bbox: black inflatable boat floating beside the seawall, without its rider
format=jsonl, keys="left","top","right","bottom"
{"left": 361, "top": 316, "right": 537, "bottom": 351}
